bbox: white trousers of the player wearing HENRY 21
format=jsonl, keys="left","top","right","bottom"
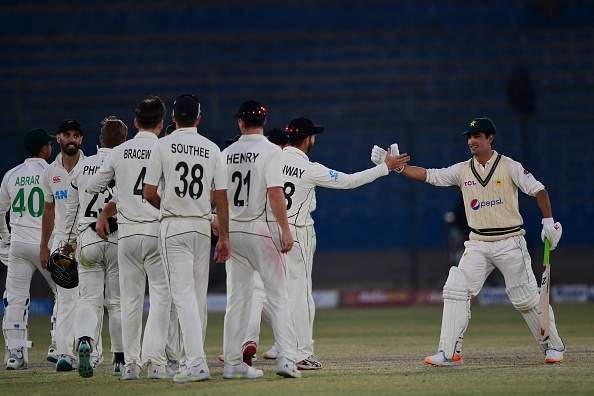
{"left": 223, "top": 221, "right": 297, "bottom": 365}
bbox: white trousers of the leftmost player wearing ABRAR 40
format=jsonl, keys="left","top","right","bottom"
{"left": 2, "top": 241, "right": 57, "bottom": 360}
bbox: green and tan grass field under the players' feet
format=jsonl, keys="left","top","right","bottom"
{"left": 0, "top": 304, "right": 594, "bottom": 396}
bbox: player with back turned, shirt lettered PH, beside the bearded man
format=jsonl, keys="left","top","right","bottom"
{"left": 66, "top": 116, "right": 128, "bottom": 378}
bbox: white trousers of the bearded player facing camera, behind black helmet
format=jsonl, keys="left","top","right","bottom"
{"left": 51, "top": 234, "right": 78, "bottom": 359}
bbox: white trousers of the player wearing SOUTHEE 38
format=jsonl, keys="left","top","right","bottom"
{"left": 159, "top": 217, "right": 210, "bottom": 367}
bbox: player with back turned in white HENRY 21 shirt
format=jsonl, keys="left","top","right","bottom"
{"left": 223, "top": 100, "right": 301, "bottom": 379}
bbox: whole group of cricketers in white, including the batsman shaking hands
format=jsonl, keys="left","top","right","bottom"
{"left": 0, "top": 95, "right": 565, "bottom": 382}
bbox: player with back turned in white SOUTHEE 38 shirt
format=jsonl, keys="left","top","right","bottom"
{"left": 144, "top": 95, "right": 229, "bottom": 382}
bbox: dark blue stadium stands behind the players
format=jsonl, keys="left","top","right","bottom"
{"left": 0, "top": 0, "right": 594, "bottom": 288}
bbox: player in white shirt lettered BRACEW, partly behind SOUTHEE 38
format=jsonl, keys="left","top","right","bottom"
{"left": 87, "top": 96, "right": 174, "bottom": 380}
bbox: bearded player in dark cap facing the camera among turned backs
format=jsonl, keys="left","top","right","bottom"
{"left": 39, "top": 119, "right": 85, "bottom": 371}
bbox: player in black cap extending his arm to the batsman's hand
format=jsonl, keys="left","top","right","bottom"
{"left": 282, "top": 117, "right": 409, "bottom": 370}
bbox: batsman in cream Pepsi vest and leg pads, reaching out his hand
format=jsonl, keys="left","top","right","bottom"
{"left": 371, "top": 117, "right": 565, "bottom": 366}
